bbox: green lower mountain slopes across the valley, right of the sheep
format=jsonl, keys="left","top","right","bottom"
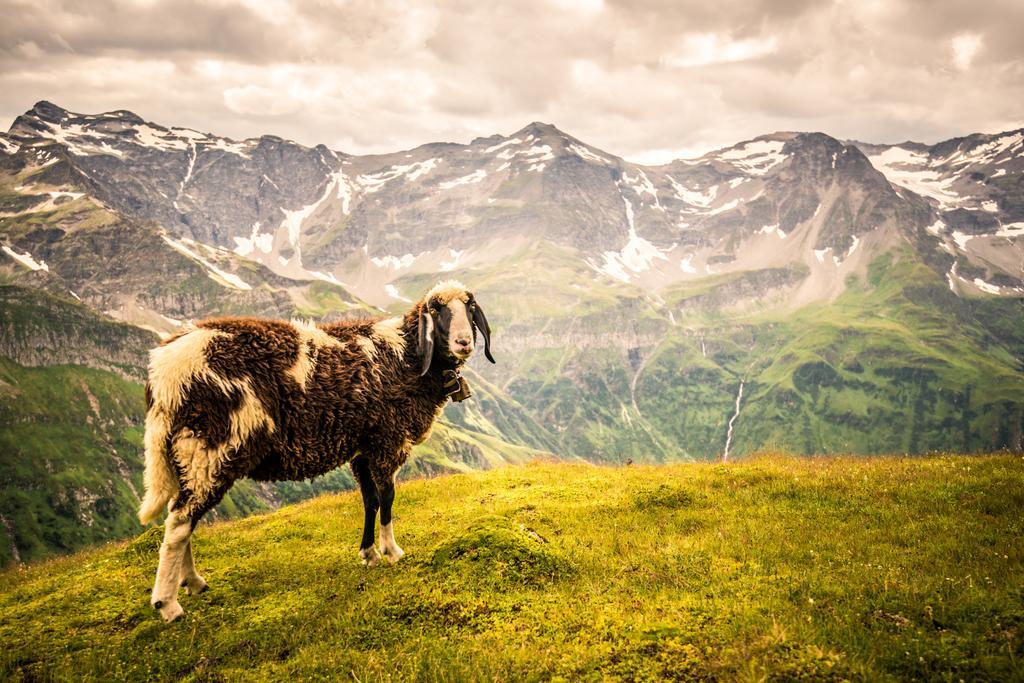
{"left": 432, "top": 239, "right": 1024, "bottom": 462}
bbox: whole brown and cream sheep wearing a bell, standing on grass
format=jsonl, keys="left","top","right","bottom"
{"left": 138, "top": 281, "right": 495, "bottom": 622}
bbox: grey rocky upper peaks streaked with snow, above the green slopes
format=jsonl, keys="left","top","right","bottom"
{"left": 6, "top": 102, "right": 1024, "bottom": 306}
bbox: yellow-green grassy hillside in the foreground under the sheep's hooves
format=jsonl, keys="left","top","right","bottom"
{"left": 0, "top": 455, "right": 1024, "bottom": 681}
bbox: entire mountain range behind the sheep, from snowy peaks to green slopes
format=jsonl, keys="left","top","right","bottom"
{"left": 0, "top": 102, "right": 1024, "bottom": 562}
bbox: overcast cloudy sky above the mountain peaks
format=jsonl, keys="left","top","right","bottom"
{"left": 0, "top": 0, "right": 1024, "bottom": 163}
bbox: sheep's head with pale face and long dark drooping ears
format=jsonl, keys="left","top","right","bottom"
{"left": 419, "top": 280, "right": 495, "bottom": 375}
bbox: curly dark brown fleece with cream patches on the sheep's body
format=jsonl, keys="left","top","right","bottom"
{"left": 146, "top": 294, "right": 479, "bottom": 521}
